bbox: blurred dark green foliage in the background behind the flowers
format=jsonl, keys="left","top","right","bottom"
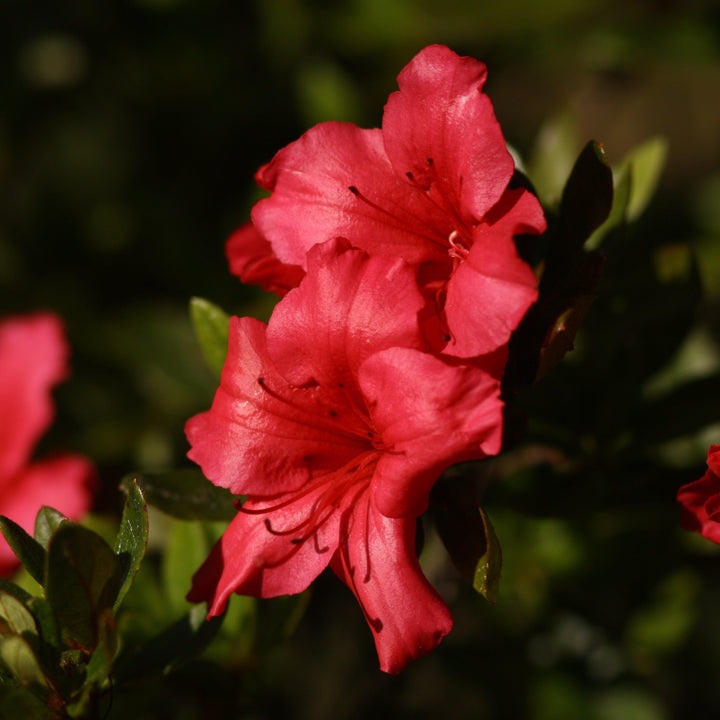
{"left": 0, "top": 0, "right": 720, "bottom": 720}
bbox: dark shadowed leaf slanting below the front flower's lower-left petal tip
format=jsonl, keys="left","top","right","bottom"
{"left": 116, "top": 604, "right": 223, "bottom": 683}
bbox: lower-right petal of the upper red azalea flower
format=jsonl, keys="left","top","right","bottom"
{"left": 443, "top": 190, "right": 545, "bottom": 358}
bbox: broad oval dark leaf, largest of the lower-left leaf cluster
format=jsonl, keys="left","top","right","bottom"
{"left": 46, "top": 522, "right": 122, "bottom": 649}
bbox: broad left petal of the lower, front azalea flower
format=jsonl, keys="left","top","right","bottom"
{"left": 185, "top": 318, "right": 366, "bottom": 496}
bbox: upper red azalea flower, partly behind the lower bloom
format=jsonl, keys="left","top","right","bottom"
{"left": 239, "top": 45, "right": 545, "bottom": 358}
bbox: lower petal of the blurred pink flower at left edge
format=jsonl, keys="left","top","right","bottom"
{"left": 0, "top": 455, "right": 96, "bottom": 577}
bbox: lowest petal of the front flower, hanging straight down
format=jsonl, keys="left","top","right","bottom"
{"left": 331, "top": 491, "right": 452, "bottom": 674}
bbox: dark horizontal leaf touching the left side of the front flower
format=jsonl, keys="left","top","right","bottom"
{"left": 122, "top": 468, "right": 237, "bottom": 521}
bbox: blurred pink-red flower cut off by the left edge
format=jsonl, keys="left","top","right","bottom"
{"left": 0, "top": 313, "right": 95, "bottom": 577}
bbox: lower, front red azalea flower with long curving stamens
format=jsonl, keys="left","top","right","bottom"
{"left": 186, "top": 240, "right": 502, "bottom": 673}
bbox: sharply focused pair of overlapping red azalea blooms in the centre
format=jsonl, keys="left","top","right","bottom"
{"left": 186, "top": 46, "right": 545, "bottom": 673}
